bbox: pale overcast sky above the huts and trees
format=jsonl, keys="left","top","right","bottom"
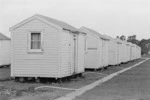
{"left": 0, "top": 0, "right": 150, "bottom": 40}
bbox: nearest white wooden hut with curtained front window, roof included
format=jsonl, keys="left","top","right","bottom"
{"left": 10, "top": 14, "right": 85, "bottom": 78}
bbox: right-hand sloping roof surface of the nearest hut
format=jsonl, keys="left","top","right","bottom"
{"left": 36, "top": 14, "right": 79, "bottom": 32}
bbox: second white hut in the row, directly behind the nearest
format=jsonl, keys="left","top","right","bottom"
{"left": 80, "top": 27, "right": 108, "bottom": 69}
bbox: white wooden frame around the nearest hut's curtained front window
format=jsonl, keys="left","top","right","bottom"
{"left": 28, "top": 31, "right": 43, "bottom": 52}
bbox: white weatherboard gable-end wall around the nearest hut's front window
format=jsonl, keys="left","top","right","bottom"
{"left": 12, "top": 19, "right": 59, "bottom": 77}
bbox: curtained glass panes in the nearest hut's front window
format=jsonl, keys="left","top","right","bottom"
{"left": 31, "top": 33, "right": 41, "bottom": 49}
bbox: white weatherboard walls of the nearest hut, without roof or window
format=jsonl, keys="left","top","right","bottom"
{"left": 11, "top": 19, "right": 85, "bottom": 78}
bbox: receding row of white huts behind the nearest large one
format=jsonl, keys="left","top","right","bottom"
{"left": 80, "top": 27, "right": 141, "bottom": 69}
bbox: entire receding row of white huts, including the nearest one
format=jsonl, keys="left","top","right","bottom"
{"left": 1, "top": 14, "right": 141, "bottom": 81}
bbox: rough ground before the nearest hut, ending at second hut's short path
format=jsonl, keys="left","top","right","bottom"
{"left": 0, "top": 73, "right": 104, "bottom": 100}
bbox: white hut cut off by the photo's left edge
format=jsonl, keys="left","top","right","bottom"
{"left": 0, "top": 33, "right": 11, "bottom": 66}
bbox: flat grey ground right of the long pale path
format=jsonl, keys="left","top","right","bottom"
{"left": 75, "top": 60, "right": 150, "bottom": 100}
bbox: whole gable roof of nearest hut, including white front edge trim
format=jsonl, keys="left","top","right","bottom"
{"left": 10, "top": 14, "right": 79, "bottom": 32}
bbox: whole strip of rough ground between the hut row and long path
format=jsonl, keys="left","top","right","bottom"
{"left": 0, "top": 59, "right": 142, "bottom": 100}
